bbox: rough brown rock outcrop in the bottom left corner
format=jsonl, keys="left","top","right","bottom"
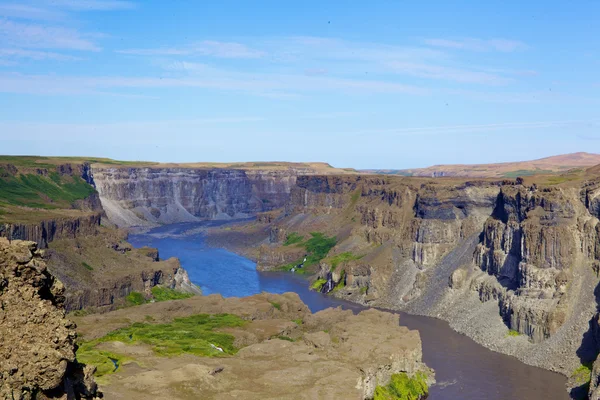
{"left": 0, "top": 238, "right": 96, "bottom": 399}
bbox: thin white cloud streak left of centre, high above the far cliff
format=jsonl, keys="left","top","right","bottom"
{"left": 117, "top": 40, "right": 265, "bottom": 58}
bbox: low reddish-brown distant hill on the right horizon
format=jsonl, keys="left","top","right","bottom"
{"left": 361, "top": 152, "right": 600, "bottom": 178}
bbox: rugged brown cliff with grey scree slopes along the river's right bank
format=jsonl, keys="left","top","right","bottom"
{"left": 254, "top": 175, "right": 600, "bottom": 375}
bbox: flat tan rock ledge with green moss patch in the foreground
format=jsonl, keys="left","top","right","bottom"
{"left": 76, "top": 293, "right": 434, "bottom": 400}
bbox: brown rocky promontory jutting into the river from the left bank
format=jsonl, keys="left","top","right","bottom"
{"left": 47, "top": 228, "right": 200, "bottom": 311}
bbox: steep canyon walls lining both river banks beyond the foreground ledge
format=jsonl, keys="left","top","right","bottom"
{"left": 0, "top": 155, "right": 600, "bottom": 396}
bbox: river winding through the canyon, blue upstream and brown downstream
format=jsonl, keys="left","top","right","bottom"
{"left": 129, "top": 222, "right": 569, "bottom": 400}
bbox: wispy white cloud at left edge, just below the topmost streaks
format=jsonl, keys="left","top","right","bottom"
{"left": 0, "top": 19, "right": 100, "bottom": 51}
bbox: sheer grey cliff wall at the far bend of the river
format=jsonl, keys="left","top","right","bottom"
{"left": 92, "top": 167, "right": 311, "bottom": 226}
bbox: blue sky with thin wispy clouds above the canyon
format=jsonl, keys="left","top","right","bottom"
{"left": 0, "top": 0, "right": 600, "bottom": 168}
